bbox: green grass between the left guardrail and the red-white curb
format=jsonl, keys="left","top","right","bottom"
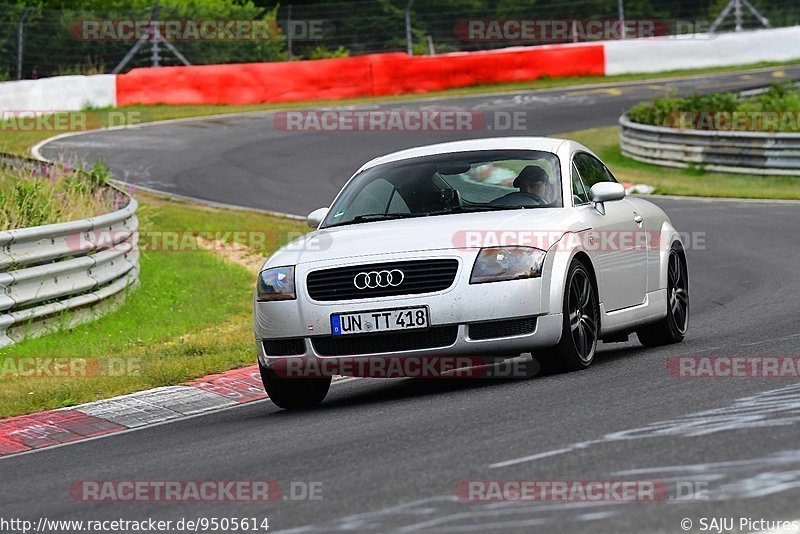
{"left": 0, "top": 193, "right": 308, "bottom": 417}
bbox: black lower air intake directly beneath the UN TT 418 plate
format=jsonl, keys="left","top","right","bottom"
{"left": 311, "top": 325, "right": 458, "bottom": 356}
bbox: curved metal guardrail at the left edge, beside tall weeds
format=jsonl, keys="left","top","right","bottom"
{"left": 0, "top": 160, "right": 139, "bottom": 346}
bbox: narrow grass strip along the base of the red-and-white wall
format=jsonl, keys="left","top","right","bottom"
{"left": 0, "top": 60, "right": 798, "bottom": 155}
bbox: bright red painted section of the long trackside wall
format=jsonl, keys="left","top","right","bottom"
{"left": 117, "top": 45, "right": 605, "bottom": 106}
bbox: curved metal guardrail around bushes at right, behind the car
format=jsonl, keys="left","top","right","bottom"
{"left": 619, "top": 115, "right": 800, "bottom": 176}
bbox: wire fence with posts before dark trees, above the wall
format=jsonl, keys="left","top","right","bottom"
{"left": 0, "top": 0, "right": 800, "bottom": 80}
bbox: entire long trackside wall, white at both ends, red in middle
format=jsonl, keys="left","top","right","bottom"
{"left": 0, "top": 26, "right": 800, "bottom": 111}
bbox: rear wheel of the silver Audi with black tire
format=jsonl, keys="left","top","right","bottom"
{"left": 636, "top": 247, "right": 689, "bottom": 347}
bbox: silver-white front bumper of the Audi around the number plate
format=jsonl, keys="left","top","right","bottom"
{"left": 254, "top": 249, "right": 562, "bottom": 365}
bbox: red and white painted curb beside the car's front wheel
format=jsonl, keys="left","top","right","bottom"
{"left": 0, "top": 365, "right": 349, "bottom": 457}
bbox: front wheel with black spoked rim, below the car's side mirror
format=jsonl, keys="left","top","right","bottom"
{"left": 534, "top": 260, "right": 600, "bottom": 373}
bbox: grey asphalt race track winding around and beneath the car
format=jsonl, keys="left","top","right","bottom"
{"left": 0, "top": 68, "right": 800, "bottom": 533}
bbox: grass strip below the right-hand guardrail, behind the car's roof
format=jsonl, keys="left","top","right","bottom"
{"left": 559, "top": 126, "right": 800, "bottom": 199}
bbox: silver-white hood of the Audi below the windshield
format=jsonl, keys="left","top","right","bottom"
{"left": 264, "top": 208, "right": 588, "bottom": 267}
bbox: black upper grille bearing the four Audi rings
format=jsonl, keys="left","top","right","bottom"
{"left": 306, "top": 260, "right": 458, "bottom": 300}
